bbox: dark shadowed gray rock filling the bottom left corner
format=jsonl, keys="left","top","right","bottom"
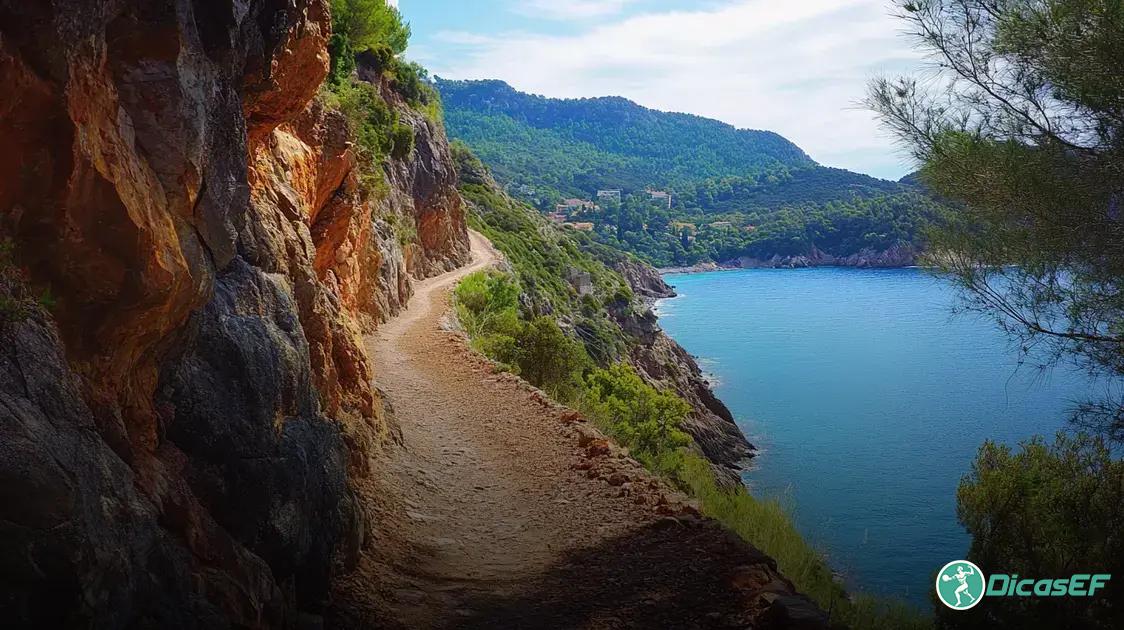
{"left": 0, "top": 318, "right": 232, "bottom": 628}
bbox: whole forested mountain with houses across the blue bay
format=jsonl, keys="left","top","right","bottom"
{"left": 437, "top": 79, "right": 939, "bottom": 267}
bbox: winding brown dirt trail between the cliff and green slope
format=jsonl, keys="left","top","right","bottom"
{"left": 333, "top": 233, "right": 827, "bottom": 628}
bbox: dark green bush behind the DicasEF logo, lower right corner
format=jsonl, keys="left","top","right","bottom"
{"left": 937, "top": 434, "right": 1124, "bottom": 629}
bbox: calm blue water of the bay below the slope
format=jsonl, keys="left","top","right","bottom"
{"left": 658, "top": 269, "right": 1091, "bottom": 608}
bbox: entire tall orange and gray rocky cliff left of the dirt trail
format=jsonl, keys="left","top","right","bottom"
{"left": 0, "top": 0, "right": 468, "bottom": 628}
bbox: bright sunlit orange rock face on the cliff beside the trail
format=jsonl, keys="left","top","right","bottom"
{"left": 245, "top": 104, "right": 381, "bottom": 417}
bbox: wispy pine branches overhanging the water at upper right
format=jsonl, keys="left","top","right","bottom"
{"left": 868, "top": 0, "right": 1124, "bottom": 441}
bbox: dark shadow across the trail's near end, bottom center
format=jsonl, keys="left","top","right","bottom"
{"left": 446, "top": 519, "right": 827, "bottom": 630}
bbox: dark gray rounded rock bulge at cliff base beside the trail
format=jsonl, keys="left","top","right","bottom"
{"left": 157, "top": 259, "right": 359, "bottom": 609}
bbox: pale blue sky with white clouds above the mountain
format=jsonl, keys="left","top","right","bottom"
{"left": 398, "top": 0, "right": 922, "bottom": 179}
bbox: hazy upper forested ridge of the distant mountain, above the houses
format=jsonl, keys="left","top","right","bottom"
{"left": 437, "top": 81, "right": 813, "bottom": 195}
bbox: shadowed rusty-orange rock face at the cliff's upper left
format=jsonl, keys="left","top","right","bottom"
{"left": 0, "top": 0, "right": 330, "bottom": 456}
